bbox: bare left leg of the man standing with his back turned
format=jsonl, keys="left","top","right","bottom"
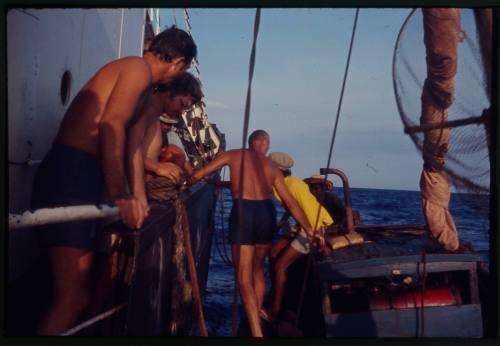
{"left": 231, "top": 244, "right": 263, "bottom": 337}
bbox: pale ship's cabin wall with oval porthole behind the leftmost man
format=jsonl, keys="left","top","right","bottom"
{"left": 7, "top": 8, "right": 150, "bottom": 278}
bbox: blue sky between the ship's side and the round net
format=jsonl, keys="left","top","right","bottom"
{"left": 161, "top": 9, "right": 422, "bottom": 190}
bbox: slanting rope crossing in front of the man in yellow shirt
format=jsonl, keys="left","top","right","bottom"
{"left": 294, "top": 8, "right": 359, "bottom": 328}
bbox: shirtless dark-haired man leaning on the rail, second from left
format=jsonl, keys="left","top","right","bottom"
{"left": 128, "top": 72, "right": 203, "bottom": 204}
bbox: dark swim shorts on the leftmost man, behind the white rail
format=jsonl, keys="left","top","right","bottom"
{"left": 31, "top": 144, "right": 105, "bottom": 251}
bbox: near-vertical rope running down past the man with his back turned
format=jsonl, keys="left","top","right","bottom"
{"left": 232, "top": 8, "right": 260, "bottom": 336}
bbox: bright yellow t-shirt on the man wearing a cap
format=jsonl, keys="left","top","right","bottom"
{"left": 273, "top": 176, "right": 333, "bottom": 229}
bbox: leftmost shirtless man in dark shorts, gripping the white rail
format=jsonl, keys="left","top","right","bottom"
{"left": 32, "top": 27, "right": 197, "bottom": 335}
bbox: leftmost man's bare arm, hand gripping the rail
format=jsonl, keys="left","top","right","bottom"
{"left": 99, "top": 60, "right": 151, "bottom": 228}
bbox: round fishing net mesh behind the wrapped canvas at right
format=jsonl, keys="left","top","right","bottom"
{"left": 393, "top": 9, "right": 491, "bottom": 201}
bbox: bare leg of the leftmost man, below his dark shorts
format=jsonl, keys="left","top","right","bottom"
{"left": 38, "top": 247, "right": 93, "bottom": 335}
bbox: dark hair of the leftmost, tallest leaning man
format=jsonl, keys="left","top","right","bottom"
{"left": 148, "top": 25, "right": 198, "bottom": 64}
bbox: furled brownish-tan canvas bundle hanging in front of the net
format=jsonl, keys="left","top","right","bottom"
{"left": 420, "top": 8, "right": 460, "bottom": 250}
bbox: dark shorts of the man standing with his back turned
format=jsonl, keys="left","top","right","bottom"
{"left": 229, "top": 199, "right": 276, "bottom": 245}
